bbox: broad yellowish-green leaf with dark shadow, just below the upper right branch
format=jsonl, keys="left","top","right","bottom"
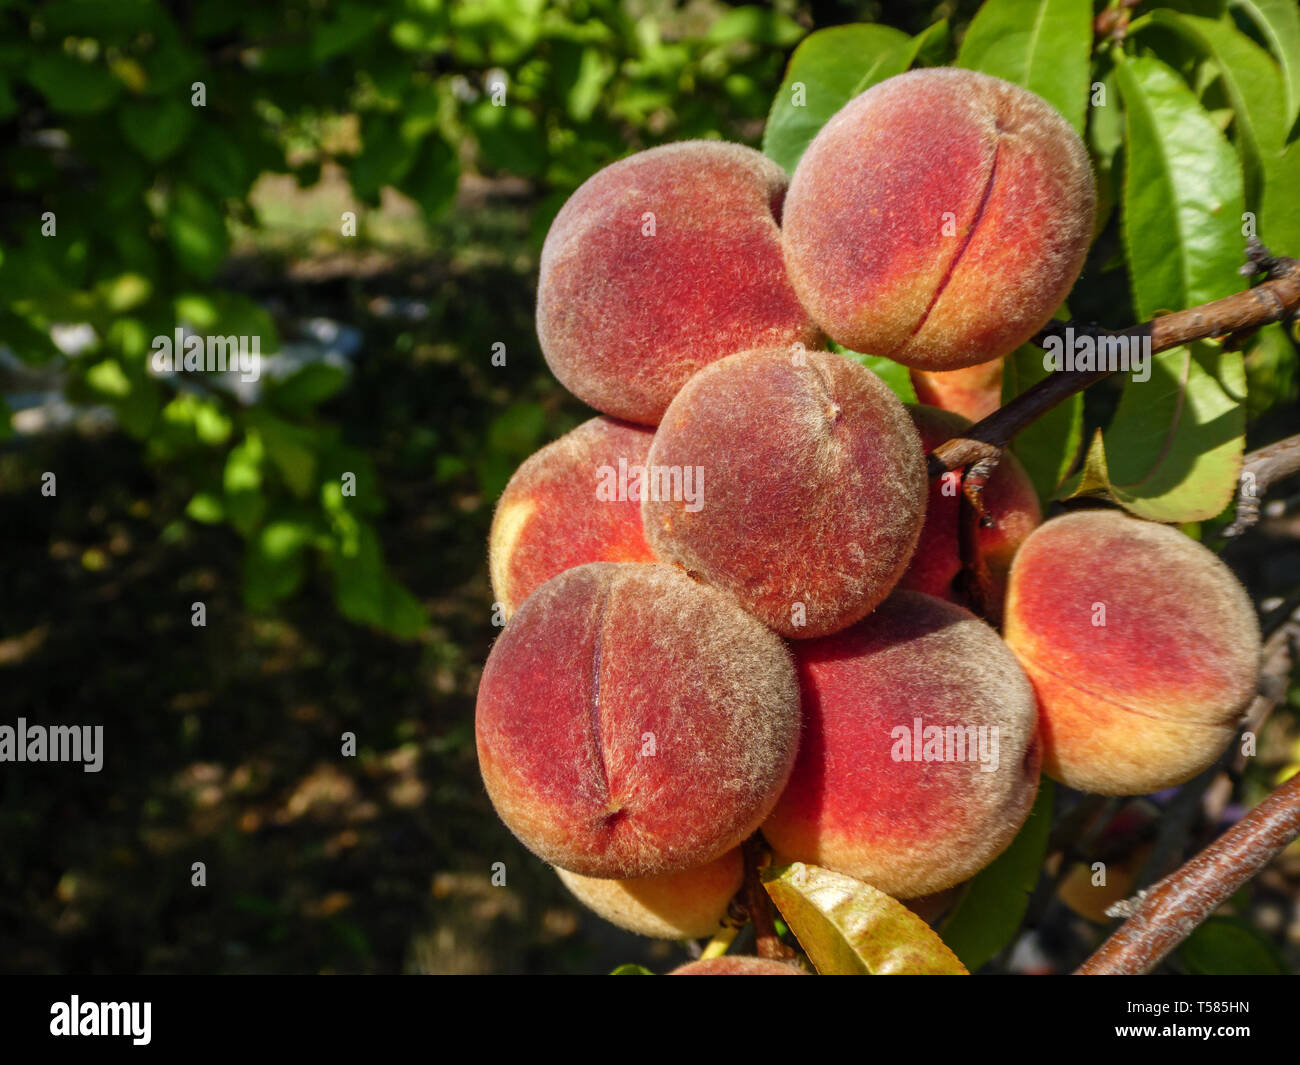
{"left": 1069, "top": 343, "right": 1245, "bottom": 523}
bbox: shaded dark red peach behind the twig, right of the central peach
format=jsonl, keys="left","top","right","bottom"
{"left": 898, "top": 404, "right": 1043, "bottom": 606}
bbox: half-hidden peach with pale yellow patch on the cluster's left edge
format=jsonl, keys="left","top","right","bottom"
{"left": 488, "top": 417, "right": 655, "bottom": 618}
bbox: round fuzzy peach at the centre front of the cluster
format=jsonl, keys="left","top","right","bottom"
{"left": 641, "top": 348, "right": 927, "bottom": 638}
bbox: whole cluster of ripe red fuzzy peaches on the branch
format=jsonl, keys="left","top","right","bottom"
{"left": 476, "top": 69, "right": 1260, "bottom": 971}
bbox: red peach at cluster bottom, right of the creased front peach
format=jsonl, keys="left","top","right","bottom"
{"left": 763, "top": 592, "right": 1040, "bottom": 899}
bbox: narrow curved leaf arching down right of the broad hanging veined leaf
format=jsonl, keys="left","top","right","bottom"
{"left": 1148, "top": 9, "right": 1286, "bottom": 202}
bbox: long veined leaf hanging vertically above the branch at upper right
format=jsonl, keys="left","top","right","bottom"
{"left": 1115, "top": 57, "right": 1244, "bottom": 319}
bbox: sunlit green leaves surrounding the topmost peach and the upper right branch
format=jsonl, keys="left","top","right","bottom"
{"left": 763, "top": 0, "right": 1300, "bottom": 523}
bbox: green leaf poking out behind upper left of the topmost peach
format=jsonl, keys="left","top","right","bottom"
{"left": 763, "top": 25, "right": 918, "bottom": 173}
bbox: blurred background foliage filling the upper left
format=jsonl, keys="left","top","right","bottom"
{"left": 0, "top": 0, "right": 803, "bottom": 637}
